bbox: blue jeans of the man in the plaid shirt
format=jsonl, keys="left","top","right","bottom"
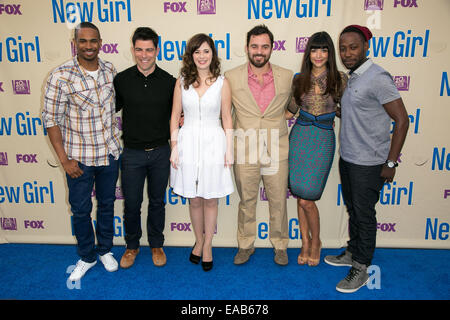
{"left": 66, "top": 155, "right": 119, "bottom": 262}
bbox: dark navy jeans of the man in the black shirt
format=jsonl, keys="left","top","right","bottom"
{"left": 121, "top": 144, "right": 170, "bottom": 249}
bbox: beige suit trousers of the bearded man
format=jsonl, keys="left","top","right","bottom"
{"left": 234, "top": 160, "right": 289, "bottom": 250}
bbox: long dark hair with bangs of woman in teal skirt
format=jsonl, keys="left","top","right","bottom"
{"left": 293, "top": 31, "right": 342, "bottom": 105}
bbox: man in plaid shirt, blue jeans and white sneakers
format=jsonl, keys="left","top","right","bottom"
{"left": 42, "top": 22, "right": 121, "bottom": 281}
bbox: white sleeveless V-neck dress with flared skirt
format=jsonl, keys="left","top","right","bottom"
{"left": 170, "top": 76, "right": 234, "bottom": 199}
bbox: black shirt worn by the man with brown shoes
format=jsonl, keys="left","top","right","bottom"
{"left": 114, "top": 65, "right": 176, "bottom": 149}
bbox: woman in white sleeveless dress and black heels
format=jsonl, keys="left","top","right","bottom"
{"left": 170, "top": 34, "right": 234, "bottom": 271}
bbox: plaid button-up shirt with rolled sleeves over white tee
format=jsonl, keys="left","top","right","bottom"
{"left": 42, "top": 57, "right": 122, "bottom": 166}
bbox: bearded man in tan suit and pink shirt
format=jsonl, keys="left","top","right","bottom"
{"left": 225, "top": 25, "right": 293, "bottom": 265}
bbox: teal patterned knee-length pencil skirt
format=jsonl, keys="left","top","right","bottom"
{"left": 289, "top": 110, "right": 336, "bottom": 201}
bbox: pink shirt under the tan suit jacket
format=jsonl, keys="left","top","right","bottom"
{"left": 248, "top": 64, "right": 275, "bottom": 114}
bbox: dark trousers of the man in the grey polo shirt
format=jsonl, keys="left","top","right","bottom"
{"left": 339, "top": 158, "right": 384, "bottom": 266}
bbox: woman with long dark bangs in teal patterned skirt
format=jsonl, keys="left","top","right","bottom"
{"left": 286, "top": 32, "right": 347, "bottom": 266}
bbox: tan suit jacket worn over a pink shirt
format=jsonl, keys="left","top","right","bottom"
{"left": 225, "top": 63, "right": 293, "bottom": 165}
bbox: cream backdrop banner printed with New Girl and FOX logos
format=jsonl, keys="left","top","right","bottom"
{"left": 0, "top": 0, "right": 450, "bottom": 248}
